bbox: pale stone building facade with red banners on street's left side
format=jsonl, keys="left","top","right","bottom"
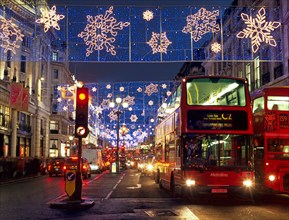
{"left": 0, "top": 0, "right": 75, "bottom": 158}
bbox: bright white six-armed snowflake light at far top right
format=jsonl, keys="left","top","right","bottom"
{"left": 237, "top": 8, "right": 281, "bottom": 53}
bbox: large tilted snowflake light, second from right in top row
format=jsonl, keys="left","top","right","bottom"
{"left": 182, "top": 8, "right": 220, "bottom": 42}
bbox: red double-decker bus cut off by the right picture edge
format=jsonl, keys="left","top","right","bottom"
{"left": 251, "top": 86, "right": 289, "bottom": 194}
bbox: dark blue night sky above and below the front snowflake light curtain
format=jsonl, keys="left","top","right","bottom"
{"left": 48, "top": 0, "right": 231, "bottom": 83}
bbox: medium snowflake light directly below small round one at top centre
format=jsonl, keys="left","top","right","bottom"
{"left": 147, "top": 32, "right": 172, "bottom": 54}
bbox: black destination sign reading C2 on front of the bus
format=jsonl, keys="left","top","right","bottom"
{"left": 188, "top": 110, "right": 248, "bottom": 130}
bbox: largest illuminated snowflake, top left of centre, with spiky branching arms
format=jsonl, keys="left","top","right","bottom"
{"left": 77, "top": 6, "right": 130, "bottom": 57}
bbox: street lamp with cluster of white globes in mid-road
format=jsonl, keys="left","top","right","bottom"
{"left": 109, "top": 97, "right": 128, "bottom": 173}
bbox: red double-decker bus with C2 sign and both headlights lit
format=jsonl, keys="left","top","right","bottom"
{"left": 154, "top": 76, "right": 255, "bottom": 196}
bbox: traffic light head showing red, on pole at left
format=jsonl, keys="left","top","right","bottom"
{"left": 75, "top": 87, "right": 89, "bottom": 138}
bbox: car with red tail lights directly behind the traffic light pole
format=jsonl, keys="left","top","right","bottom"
{"left": 63, "top": 157, "right": 91, "bottom": 179}
